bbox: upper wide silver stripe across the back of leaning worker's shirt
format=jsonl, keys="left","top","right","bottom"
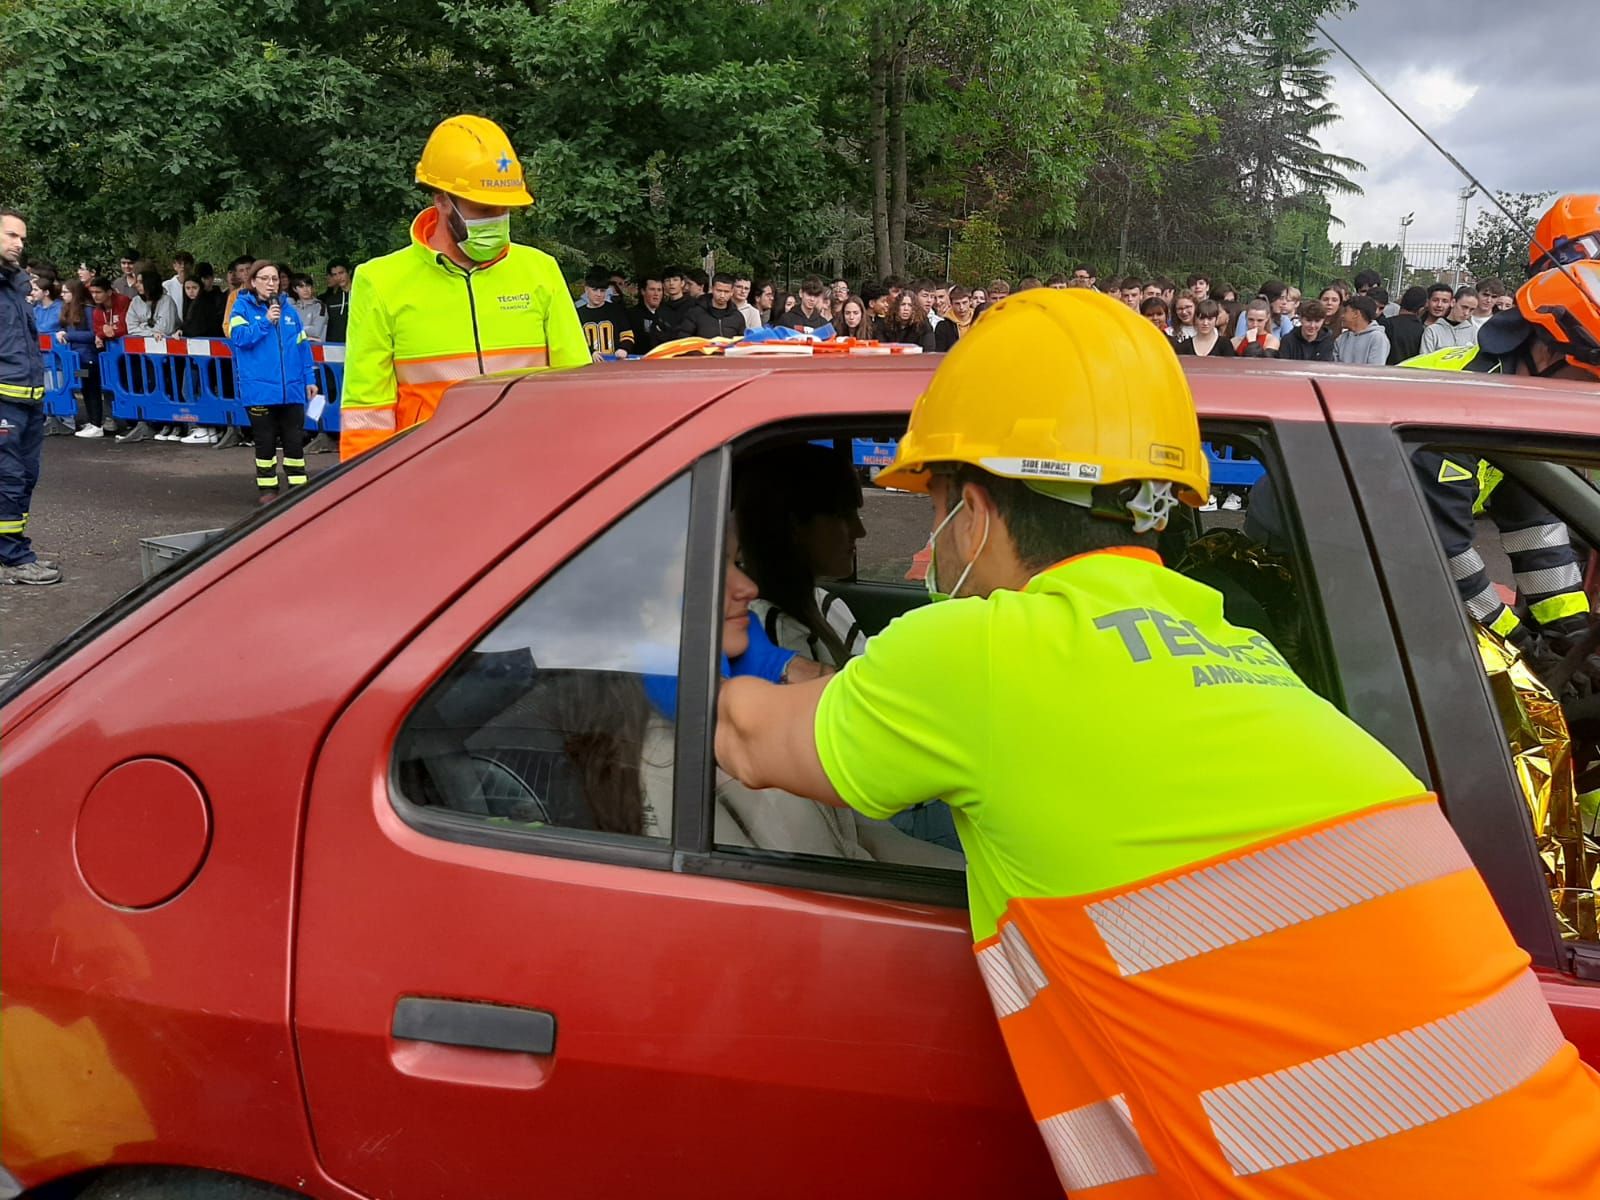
{"left": 1085, "top": 803, "right": 1472, "bottom": 974}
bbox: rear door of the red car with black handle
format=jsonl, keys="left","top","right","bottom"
{"left": 294, "top": 429, "right": 1059, "bottom": 1200}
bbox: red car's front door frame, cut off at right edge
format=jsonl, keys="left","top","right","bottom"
{"left": 1320, "top": 374, "right": 1600, "bottom": 1062}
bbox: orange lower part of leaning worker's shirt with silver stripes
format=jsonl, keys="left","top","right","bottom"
{"left": 976, "top": 797, "right": 1600, "bottom": 1200}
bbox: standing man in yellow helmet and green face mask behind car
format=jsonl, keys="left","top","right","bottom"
{"left": 339, "top": 115, "right": 590, "bottom": 459}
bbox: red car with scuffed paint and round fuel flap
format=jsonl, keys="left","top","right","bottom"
{"left": 0, "top": 358, "right": 1600, "bottom": 1200}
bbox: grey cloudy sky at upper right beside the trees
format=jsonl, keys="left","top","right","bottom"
{"left": 1322, "top": 0, "right": 1580, "bottom": 254}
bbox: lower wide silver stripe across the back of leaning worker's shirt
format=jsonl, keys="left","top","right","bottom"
{"left": 1200, "top": 973, "right": 1563, "bottom": 1174}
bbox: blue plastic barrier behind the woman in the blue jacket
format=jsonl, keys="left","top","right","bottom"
{"left": 95, "top": 338, "right": 344, "bottom": 434}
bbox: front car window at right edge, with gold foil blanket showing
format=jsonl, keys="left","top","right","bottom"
{"left": 1413, "top": 443, "right": 1600, "bottom": 942}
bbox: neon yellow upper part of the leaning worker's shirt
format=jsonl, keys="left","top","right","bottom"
{"left": 816, "top": 550, "right": 1427, "bottom": 941}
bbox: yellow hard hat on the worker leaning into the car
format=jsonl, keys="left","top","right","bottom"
{"left": 875, "top": 288, "right": 1210, "bottom": 506}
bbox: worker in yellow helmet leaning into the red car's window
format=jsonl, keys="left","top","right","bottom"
{"left": 717, "top": 288, "right": 1600, "bottom": 1200}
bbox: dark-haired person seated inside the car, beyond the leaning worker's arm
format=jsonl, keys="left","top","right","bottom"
{"left": 734, "top": 443, "right": 867, "bottom": 669}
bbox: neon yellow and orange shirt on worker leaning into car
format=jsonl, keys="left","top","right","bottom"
{"left": 814, "top": 550, "right": 1600, "bottom": 1200}
